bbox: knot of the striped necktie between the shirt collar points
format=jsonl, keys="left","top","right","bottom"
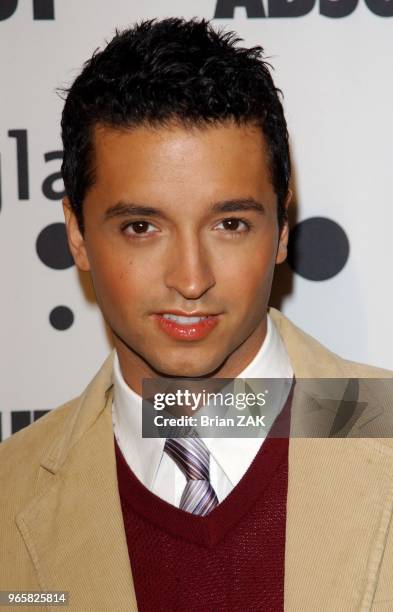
{"left": 164, "top": 437, "right": 210, "bottom": 480}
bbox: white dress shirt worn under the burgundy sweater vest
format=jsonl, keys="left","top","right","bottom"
{"left": 112, "top": 315, "right": 293, "bottom": 507}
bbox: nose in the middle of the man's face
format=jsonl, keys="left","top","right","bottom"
{"left": 165, "top": 235, "right": 216, "bottom": 300}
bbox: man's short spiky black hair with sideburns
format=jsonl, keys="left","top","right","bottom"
{"left": 61, "top": 18, "right": 291, "bottom": 233}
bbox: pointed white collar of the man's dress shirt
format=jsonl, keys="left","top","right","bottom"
{"left": 112, "top": 315, "right": 293, "bottom": 489}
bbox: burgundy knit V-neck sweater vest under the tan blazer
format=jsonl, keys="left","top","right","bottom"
{"left": 115, "top": 387, "right": 293, "bottom": 612}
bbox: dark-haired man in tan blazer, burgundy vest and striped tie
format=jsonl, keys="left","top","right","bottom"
{"left": 0, "top": 19, "right": 393, "bottom": 611}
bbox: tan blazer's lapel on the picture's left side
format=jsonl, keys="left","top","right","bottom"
{"left": 16, "top": 358, "right": 137, "bottom": 611}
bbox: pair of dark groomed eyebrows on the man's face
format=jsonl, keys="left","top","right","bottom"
{"left": 104, "top": 198, "right": 266, "bottom": 221}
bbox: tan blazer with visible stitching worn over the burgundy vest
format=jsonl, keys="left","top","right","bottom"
{"left": 0, "top": 309, "right": 393, "bottom": 612}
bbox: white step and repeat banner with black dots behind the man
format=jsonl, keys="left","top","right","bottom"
{"left": 0, "top": 0, "right": 393, "bottom": 439}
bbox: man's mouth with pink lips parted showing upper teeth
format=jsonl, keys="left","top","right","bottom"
{"left": 153, "top": 311, "right": 220, "bottom": 341}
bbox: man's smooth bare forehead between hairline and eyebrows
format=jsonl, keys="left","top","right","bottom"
{"left": 87, "top": 122, "right": 273, "bottom": 208}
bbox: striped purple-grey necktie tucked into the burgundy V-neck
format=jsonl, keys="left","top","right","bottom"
{"left": 164, "top": 437, "right": 218, "bottom": 516}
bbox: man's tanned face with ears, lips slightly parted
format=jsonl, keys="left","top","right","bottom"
{"left": 64, "top": 123, "right": 287, "bottom": 388}
